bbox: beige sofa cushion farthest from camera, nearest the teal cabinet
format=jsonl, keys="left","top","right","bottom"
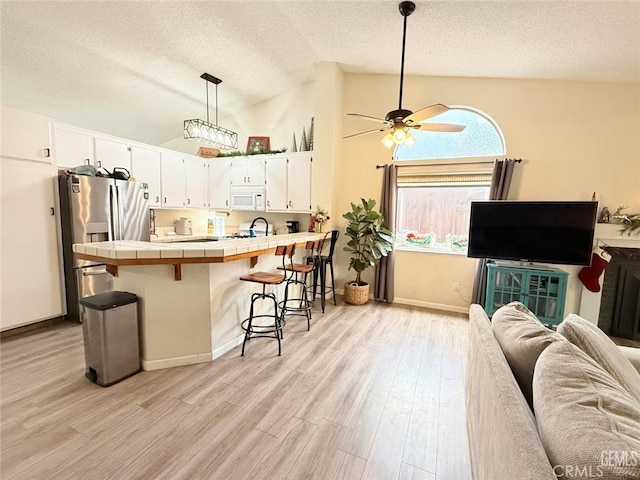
{"left": 491, "top": 302, "right": 565, "bottom": 405}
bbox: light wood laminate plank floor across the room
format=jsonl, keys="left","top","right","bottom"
{"left": 0, "top": 302, "right": 471, "bottom": 480}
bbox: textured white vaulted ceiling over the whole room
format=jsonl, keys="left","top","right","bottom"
{"left": 0, "top": 0, "right": 640, "bottom": 144}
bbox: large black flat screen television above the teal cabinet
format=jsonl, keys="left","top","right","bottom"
{"left": 467, "top": 200, "right": 598, "bottom": 265}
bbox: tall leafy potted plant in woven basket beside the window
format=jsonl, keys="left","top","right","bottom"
{"left": 342, "top": 198, "right": 393, "bottom": 305}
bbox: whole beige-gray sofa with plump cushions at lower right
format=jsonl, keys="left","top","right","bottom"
{"left": 465, "top": 302, "right": 640, "bottom": 480}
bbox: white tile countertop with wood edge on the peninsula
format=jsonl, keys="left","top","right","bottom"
{"left": 73, "top": 232, "right": 324, "bottom": 265}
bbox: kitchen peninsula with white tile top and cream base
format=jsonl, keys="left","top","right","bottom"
{"left": 73, "top": 233, "right": 324, "bottom": 370}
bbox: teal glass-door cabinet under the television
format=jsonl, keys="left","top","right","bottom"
{"left": 485, "top": 262, "right": 568, "bottom": 326}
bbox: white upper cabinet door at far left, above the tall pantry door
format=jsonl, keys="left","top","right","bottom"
{"left": 0, "top": 105, "right": 55, "bottom": 165}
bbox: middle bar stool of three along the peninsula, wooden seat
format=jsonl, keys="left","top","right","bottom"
{"left": 278, "top": 240, "right": 322, "bottom": 330}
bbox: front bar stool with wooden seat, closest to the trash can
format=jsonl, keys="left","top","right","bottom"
{"left": 240, "top": 245, "right": 295, "bottom": 356}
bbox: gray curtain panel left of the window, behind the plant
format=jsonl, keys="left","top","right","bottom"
{"left": 374, "top": 165, "right": 398, "bottom": 302}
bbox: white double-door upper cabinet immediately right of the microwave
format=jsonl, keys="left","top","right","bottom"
{"left": 267, "top": 152, "right": 312, "bottom": 213}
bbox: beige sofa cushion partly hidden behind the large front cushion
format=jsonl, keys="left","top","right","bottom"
{"left": 558, "top": 314, "right": 640, "bottom": 402}
